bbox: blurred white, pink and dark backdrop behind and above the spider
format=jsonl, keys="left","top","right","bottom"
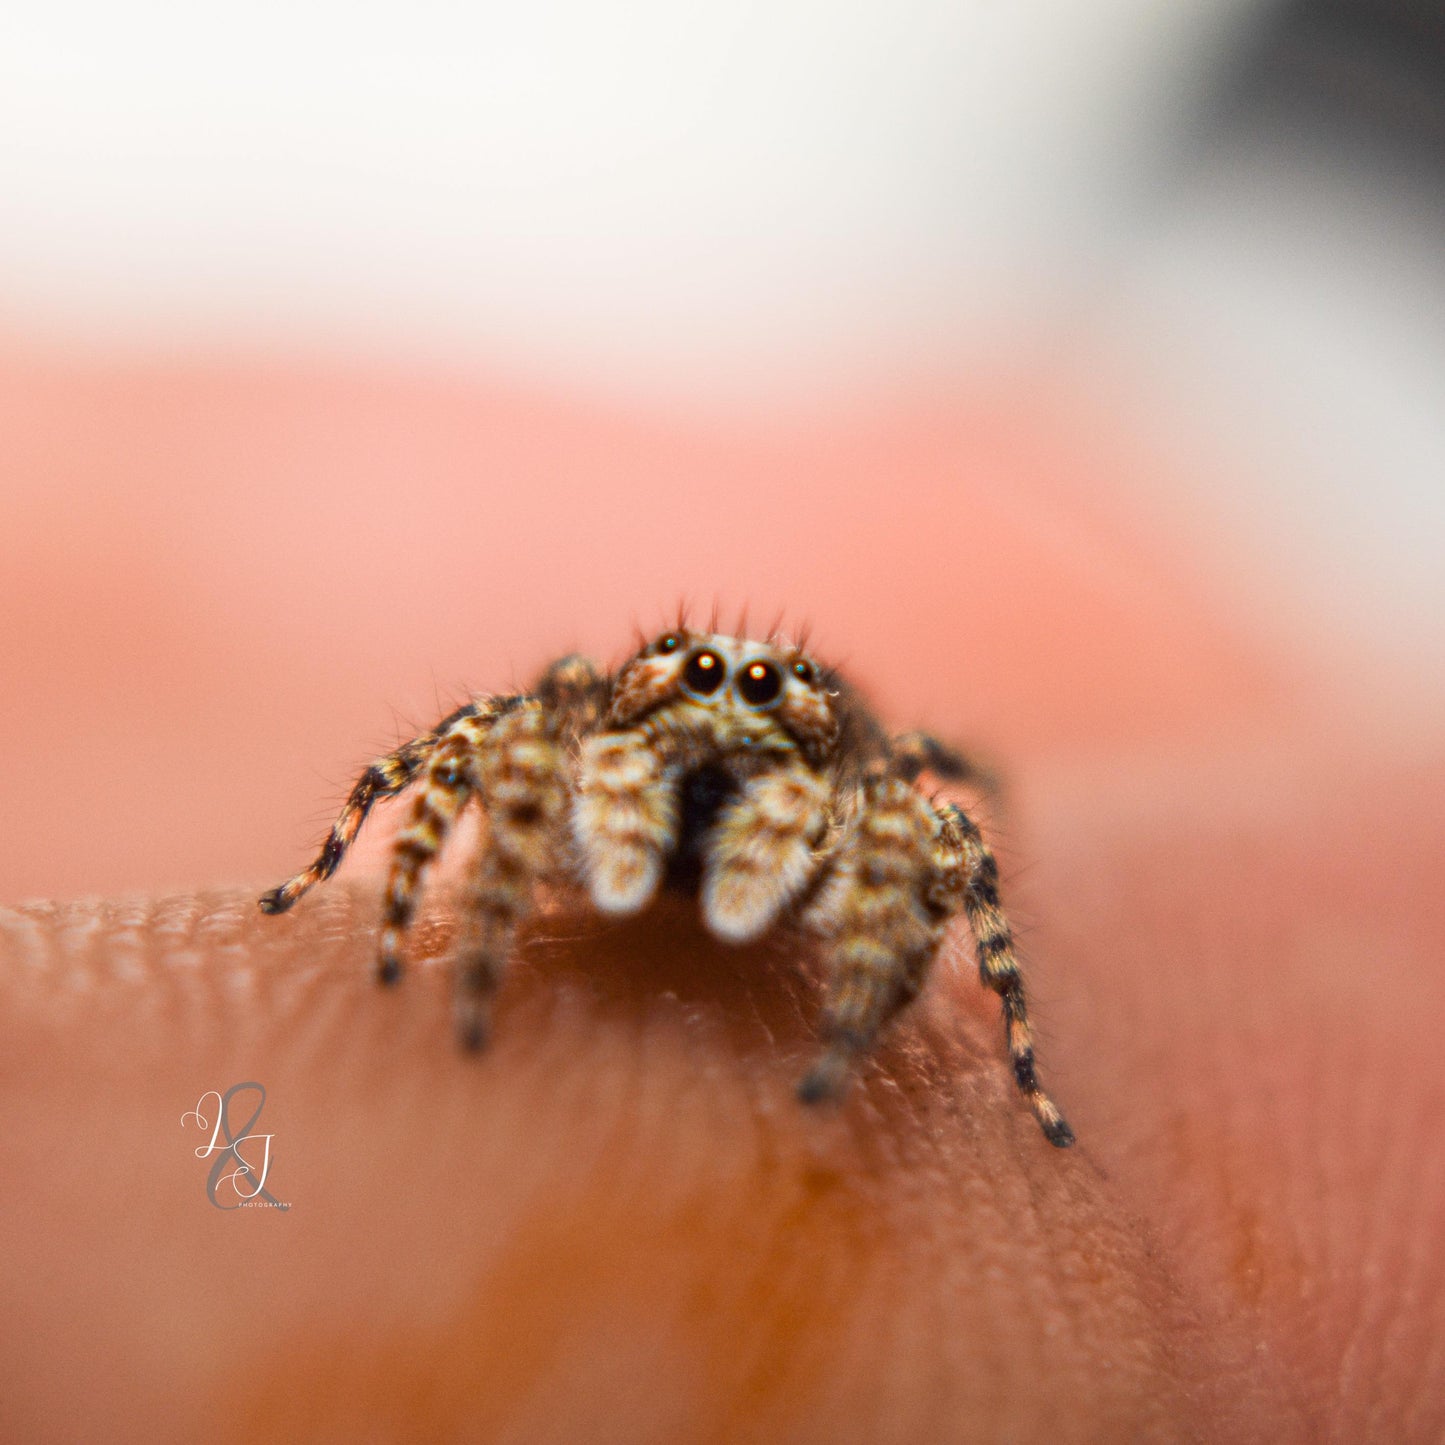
{"left": 0, "top": 0, "right": 1445, "bottom": 900}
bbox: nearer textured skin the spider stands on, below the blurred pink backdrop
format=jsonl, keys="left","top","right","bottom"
{"left": 0, "top": 739, "right": 1445, "bottom": 1441}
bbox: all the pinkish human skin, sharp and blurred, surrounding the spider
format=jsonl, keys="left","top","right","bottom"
{"left": 0, "top": 343, "right": 1445, "bottom": 1441}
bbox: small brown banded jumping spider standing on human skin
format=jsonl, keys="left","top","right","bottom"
{"left": 260, "top": 626, "right": 1074, "bottom": 1146}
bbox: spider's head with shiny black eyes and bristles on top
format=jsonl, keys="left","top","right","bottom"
{"left": 608, "top": 627, "right": 838, "bottom": 762}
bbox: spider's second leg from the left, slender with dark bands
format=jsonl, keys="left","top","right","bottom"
{"left": 376, "top": 698, "right": 499, "bottom": 984}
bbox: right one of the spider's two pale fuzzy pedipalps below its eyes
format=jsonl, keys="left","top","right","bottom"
{"left": 702, "top": 756, "right": 831, "bottom": 944}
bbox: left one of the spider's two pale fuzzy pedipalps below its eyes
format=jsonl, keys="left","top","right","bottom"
{"left": 572, "top": 730, "right": 679, "bottom": 913}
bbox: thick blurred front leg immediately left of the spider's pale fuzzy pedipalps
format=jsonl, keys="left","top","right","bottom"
{"left": 455, "top": 705, "right": 568, "bottom": 1049}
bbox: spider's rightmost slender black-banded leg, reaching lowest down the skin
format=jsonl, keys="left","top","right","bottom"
{"left": 938, "top": 803, "right": 1074, "bottom": 1149}
